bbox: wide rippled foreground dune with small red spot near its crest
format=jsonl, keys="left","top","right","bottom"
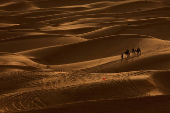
{"left": 1, "top": 71, "right": 169, "bottom": 112}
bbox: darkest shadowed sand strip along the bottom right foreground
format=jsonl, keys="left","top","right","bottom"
{"left": 20, "top": 96, "right": 169, "bottom": 113}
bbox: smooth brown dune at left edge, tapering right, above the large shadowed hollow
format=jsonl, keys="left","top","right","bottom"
{"left": 0, "top": 35, "right": 85, "bottom": 53}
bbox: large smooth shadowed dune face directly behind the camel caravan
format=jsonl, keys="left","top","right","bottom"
{"left": 19, "top": 35, "right": 169, "bottom": 65}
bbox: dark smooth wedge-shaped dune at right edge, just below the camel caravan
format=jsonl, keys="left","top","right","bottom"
{"left": 102, "top": 54, "right": 170, "bottom": 72}
